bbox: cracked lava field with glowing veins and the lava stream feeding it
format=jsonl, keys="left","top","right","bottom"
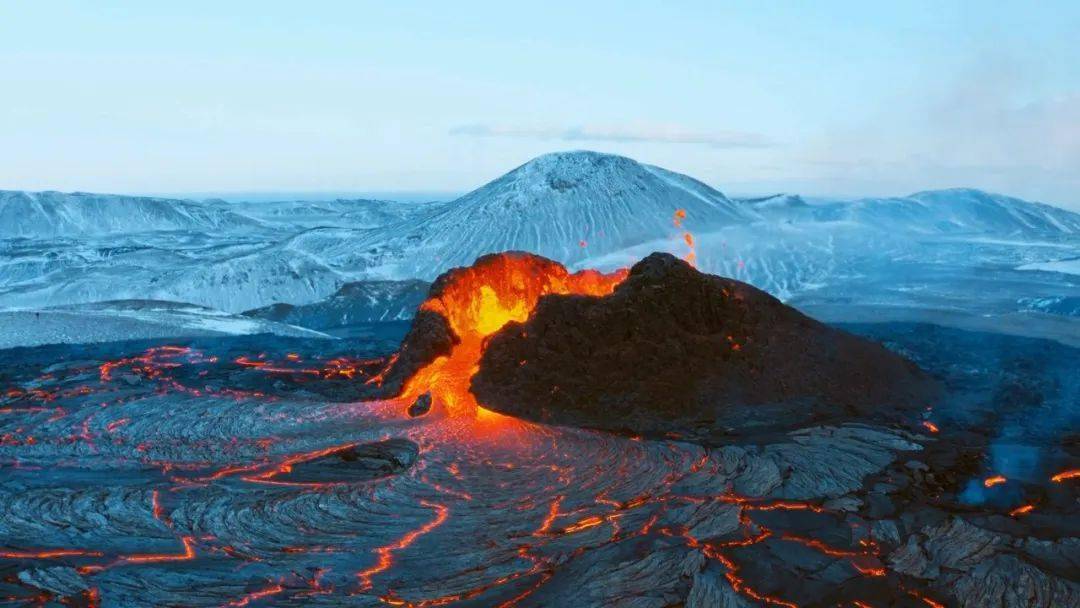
{"left": 0, "top": 253, "right": 1076, "bottom": 607}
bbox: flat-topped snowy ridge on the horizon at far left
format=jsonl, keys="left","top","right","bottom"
{"left": 0, "top": 190, "right": 260, "bottom": 239}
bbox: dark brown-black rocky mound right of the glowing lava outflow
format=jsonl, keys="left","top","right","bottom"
{"left": 472, "top": 249, "right": 939, "bottom": 440}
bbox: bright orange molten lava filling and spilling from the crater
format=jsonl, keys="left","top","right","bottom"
{"left": 401, "top": 252, "right": 627, "bottom": 415}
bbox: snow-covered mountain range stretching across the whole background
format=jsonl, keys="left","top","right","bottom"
{"left": 0, "top": 152, "right": 1080, "bottom": 336}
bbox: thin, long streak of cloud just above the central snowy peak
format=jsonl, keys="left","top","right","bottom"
{"left": 449, "top": 124, "right": 774, "bottom": 148}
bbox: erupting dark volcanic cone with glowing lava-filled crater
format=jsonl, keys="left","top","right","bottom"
{"left": 383, "top": 253, "right": 937, "bottom": 440}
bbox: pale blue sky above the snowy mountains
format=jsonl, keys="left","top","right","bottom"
{"left": 0, "top": 0, "right": 1080, "bottom": 211}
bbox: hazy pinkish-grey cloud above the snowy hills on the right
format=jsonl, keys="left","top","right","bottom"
{"left": 788, "top": 55, "right": 1080, "bottom": 208}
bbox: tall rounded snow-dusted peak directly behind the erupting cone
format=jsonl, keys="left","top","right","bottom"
{"left": 330, "top": 152, "right": 758, "bottom": 279}
